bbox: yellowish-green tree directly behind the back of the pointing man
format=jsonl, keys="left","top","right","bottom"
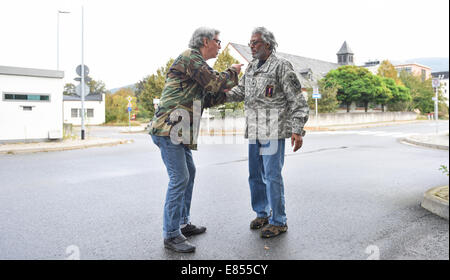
{"left": 136, "top": 58, "right": 174, "bottom": 117}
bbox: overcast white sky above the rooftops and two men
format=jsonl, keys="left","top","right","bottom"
{"left": 0, "top": 0, "right": 449, "bottom": 89}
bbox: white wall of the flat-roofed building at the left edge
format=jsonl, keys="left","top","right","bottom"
{"left": 0, "top": 74, "right": 64, "bottom": 141}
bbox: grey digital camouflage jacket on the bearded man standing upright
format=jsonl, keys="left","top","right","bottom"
{"left": 226, "top": 53, "right": 309, "bottom": 139}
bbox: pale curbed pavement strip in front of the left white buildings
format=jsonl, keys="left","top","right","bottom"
{"left": 0, "top": 140, "right": 134, "bottom": 155}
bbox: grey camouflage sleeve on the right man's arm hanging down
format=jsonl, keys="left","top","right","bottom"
{"left": 280, "top": 62, "right": 309, "bottom": 135}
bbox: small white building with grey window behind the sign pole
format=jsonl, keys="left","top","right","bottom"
{"left": 64, "top": 93, "right": 105, "bottom": 125}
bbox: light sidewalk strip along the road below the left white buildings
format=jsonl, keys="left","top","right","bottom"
{"left": 0, "top": 137, "right": 133, "bottom": 155}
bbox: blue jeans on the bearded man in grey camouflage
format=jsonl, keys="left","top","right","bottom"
{"left": 248, "top": 139, "right": 287, "bottom": 226}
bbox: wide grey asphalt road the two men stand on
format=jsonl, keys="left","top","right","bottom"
{"left": 0, "top": 122, "right": 449, "bottom": 260}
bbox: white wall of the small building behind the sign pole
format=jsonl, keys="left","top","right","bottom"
{"left": 64, "top": 96, "right": 105, "bottom": 125}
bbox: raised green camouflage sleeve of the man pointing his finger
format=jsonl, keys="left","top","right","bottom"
{"left": 186, "top": 51, "right": 238, "bottom": 93}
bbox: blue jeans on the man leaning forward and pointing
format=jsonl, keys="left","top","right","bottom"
{"left": 152, "top": 135, "right": 195, "bottom": 239}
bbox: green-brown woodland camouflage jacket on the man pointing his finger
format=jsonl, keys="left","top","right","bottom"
{"left": 150, "top": 49, "right": 238, "bottom": 150}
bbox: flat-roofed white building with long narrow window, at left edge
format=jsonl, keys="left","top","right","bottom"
{"left": 0, "top": 66, "right": 64, "bottom": 143}
